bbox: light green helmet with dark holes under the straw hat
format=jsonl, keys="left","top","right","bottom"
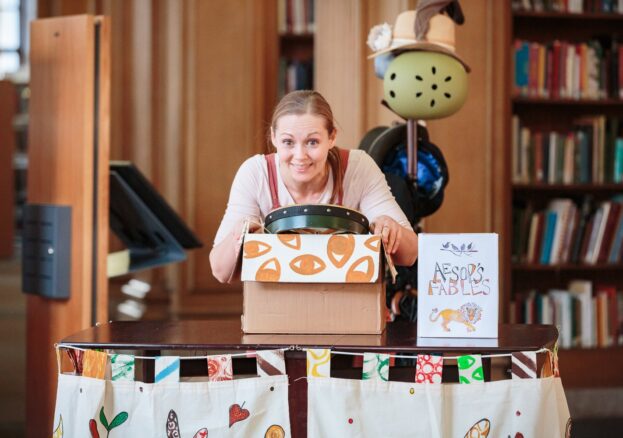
{"left": 383, "top": 50, "right": 467, "bottom": 120}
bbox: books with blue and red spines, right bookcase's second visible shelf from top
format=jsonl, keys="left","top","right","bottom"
{"left": 512, "top": 38, "right": 623, "bottom": 100}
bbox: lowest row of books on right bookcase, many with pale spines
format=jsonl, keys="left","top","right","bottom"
{"left": 510, "top": 280, "right": 623, "bottom": 348}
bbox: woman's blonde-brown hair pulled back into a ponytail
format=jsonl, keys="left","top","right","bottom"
{"left": 269, "top": 90, "right": 344, "bottom": 203}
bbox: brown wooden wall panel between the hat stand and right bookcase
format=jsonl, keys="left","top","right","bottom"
{"left": 424, "top": 0, "right": 495, "bottom": 233}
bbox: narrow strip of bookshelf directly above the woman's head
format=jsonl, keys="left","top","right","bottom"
{"left": 277, "top": 0, "right": 315, "bottom": 99}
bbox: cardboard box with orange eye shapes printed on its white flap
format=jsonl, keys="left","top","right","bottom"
{"left": 241, "top": 234, "right": 386, "bottom": 334}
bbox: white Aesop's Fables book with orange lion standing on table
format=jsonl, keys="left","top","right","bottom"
{"left": 417, "top": 233, "right": 499, "bottom": 338}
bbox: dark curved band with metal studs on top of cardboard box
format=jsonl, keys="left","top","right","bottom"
{"left": 264, "top": 204, "right": 370, "bottom": 234}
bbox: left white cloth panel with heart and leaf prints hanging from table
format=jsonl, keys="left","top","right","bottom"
{"left": 54, "top": 354, "right": 291, "bottom": 438}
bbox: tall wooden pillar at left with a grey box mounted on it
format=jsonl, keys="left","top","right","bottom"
{"left": 26, "top": 15, "right": 110, "bottom": 437}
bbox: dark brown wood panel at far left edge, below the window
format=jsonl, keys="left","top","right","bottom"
{"left": 0, "top": 81, "right": 17, "bottom": 258}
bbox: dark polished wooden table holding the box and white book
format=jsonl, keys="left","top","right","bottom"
{"left": 61, "top": 320, "right": 558, "bottom": 438}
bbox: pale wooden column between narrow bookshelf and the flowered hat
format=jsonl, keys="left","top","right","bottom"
{"left": 314, "top": 0, "right": 416, "bottom": 144}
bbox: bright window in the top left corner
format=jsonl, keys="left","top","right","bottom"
{"left": 0, "top": 0, "right": 21, "bottom": 78}
